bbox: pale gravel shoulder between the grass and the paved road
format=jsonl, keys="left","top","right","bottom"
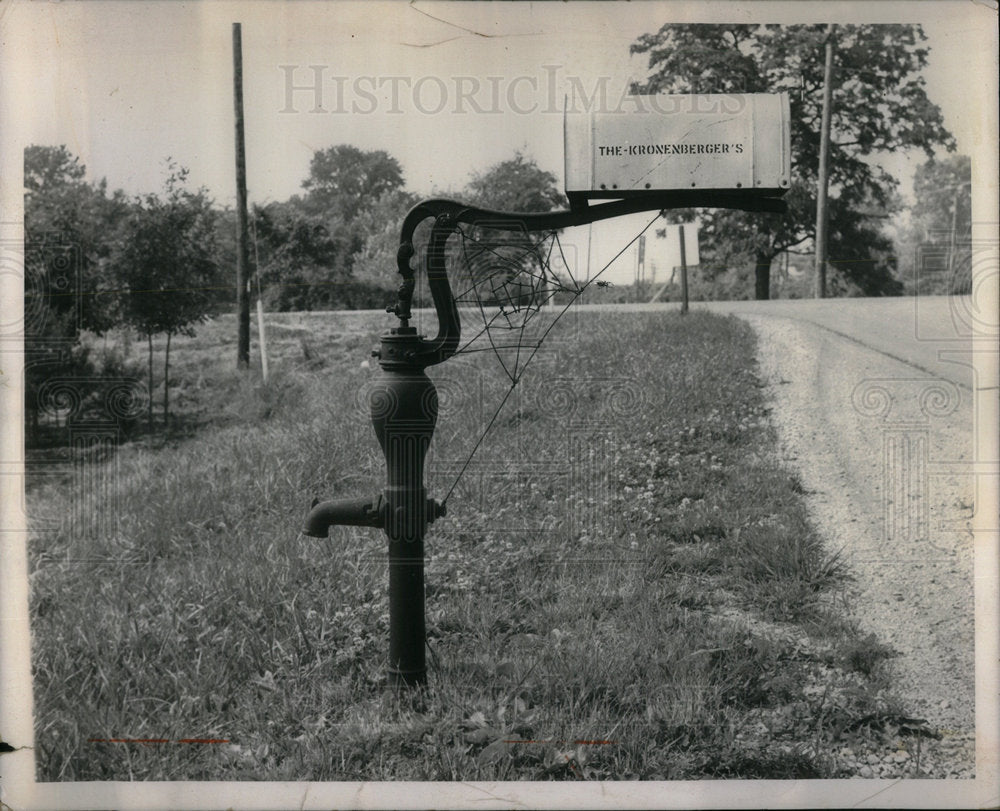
{"left": 743, "top": 315, "right": 975, "bottom": 777}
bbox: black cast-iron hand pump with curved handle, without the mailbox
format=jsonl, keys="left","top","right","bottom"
{"left": 303, "top": 190, "right": 785, "bottom": 686}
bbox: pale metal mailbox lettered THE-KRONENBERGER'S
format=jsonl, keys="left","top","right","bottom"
{"left": 564, "top": 93, "right": 791, "bottom": 203}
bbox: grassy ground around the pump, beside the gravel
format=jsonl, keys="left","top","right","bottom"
{"left": 29, "top": 311, "right": 905, "bottom": 780}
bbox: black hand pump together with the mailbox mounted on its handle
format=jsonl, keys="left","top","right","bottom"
{"left": 303, "top": 94, "right": 790, "bottom": 686}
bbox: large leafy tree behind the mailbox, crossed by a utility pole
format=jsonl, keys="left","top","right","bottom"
{"left": 631, "top": 24, "right": 954, "bottom": 298}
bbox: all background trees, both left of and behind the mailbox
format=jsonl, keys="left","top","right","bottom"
{"left": 24, "top": 24, "right": 971, "bottom": 444}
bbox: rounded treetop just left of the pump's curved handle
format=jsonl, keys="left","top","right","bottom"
{"left": 302, "top": 144, "right": 403, "bottom": 220}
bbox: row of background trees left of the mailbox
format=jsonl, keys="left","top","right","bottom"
{"left": 24, "top": 144, "right": 564, "bottom": 440}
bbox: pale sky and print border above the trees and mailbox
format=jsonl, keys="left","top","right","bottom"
{"left": 0, "top": 0, "right": 996, "bottom": 286}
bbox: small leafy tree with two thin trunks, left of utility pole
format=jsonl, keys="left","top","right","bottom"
{"left": 109, "top": 163, "right": 226, "bottom": 427}
